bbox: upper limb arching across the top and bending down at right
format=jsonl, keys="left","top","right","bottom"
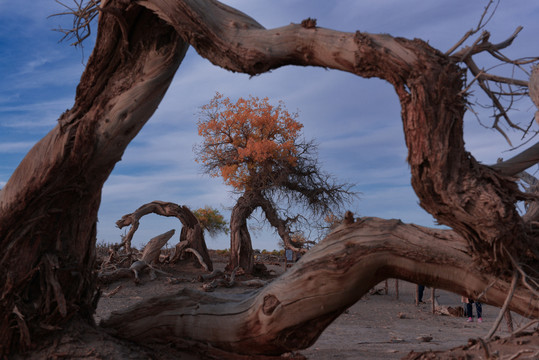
{"left": 141, "top": 0, "right": 539, "bottom": 273}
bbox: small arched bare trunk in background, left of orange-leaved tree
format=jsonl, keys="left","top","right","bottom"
{"left": 116, "top": 200, "right": 213, "bottom": 271}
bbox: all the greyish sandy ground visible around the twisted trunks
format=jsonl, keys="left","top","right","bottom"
{"left": 96, "top": 255, "right": 526, "bottom": 360}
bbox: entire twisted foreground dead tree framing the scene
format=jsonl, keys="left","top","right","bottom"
{"left": 0, "top": 0, "right": 539, "bottom": 357}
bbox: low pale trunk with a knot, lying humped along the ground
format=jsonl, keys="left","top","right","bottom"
{"left": 101, "top": 218, "right": 539, "bottom": 355}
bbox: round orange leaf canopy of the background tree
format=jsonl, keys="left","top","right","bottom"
{"left": 198, "top": 93, "right": 303, "bottom": 190}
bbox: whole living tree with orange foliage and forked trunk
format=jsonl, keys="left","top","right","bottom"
{"left": 195, "top": 93, "right": 353, "bottom": 272}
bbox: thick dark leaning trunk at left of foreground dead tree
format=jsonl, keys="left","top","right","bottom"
{"left": 0, "top": 2, "right": 188, "bottom": 357}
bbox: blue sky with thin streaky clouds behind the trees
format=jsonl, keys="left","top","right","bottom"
{"left": 0, "top": 0, "right": 539, "bottom": 250}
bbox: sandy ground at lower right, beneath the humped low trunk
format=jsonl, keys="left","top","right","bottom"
{"left": 301, "top": 279, "right": 525, "bottom": 360}
